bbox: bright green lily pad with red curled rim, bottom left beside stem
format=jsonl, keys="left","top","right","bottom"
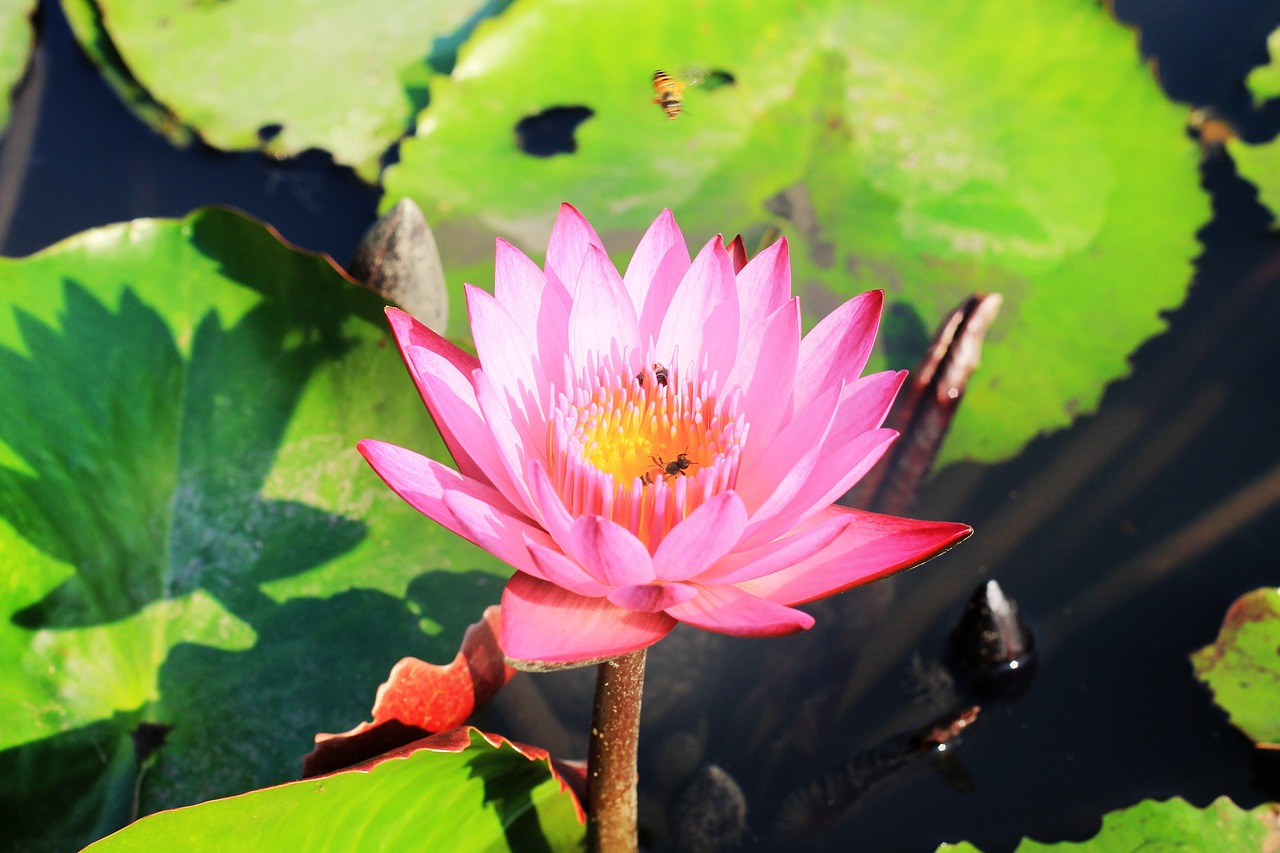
{"left": 88, "top": 729, "right": 584, "bottom": 853}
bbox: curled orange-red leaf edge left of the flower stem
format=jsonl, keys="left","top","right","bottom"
{"left": 302, "top": 607, "right": 516, "bottom": 776}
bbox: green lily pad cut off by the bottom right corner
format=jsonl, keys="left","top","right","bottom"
{"left": 938, "top": 797, "right": 1280, "bottom": 853}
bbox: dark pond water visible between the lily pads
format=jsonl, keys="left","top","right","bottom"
{"left": 0, "top": 0, "right": 1280, "bottom": 852}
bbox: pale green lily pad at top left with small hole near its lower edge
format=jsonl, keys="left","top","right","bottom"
{"left": 63, "top": 0, "right": 506, "bottom": 182}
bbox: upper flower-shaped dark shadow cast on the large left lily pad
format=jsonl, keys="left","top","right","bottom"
{"left": 0, "top": 280, "right": 365, "bottom": 630}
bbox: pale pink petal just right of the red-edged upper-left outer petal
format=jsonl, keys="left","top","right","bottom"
{"left": 465, "top": 284, "right": 550, "bottom": 423}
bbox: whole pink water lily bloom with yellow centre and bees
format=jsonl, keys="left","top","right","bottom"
{"left": 360, "top": 205, "right": 972, "bottom": 669}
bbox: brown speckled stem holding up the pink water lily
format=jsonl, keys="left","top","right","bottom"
{"left": 586, "top": 649, "right": 645, "bottom": 853}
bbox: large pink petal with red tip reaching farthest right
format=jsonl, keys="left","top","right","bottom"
{"left": 739, "top": 506, "right": 973, "bottom": 605}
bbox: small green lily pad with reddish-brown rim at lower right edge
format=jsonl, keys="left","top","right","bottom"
{"left": 1192, "top": 588, "right": 1280, "bottom": 744}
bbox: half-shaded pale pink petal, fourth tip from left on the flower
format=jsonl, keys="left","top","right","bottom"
{"left": 493, "top": 240, "right": 570, "bottom": 370}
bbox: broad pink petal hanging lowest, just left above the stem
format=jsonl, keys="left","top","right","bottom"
{"left": 500, "top": 573, "right": 676, "bottom": 669}
